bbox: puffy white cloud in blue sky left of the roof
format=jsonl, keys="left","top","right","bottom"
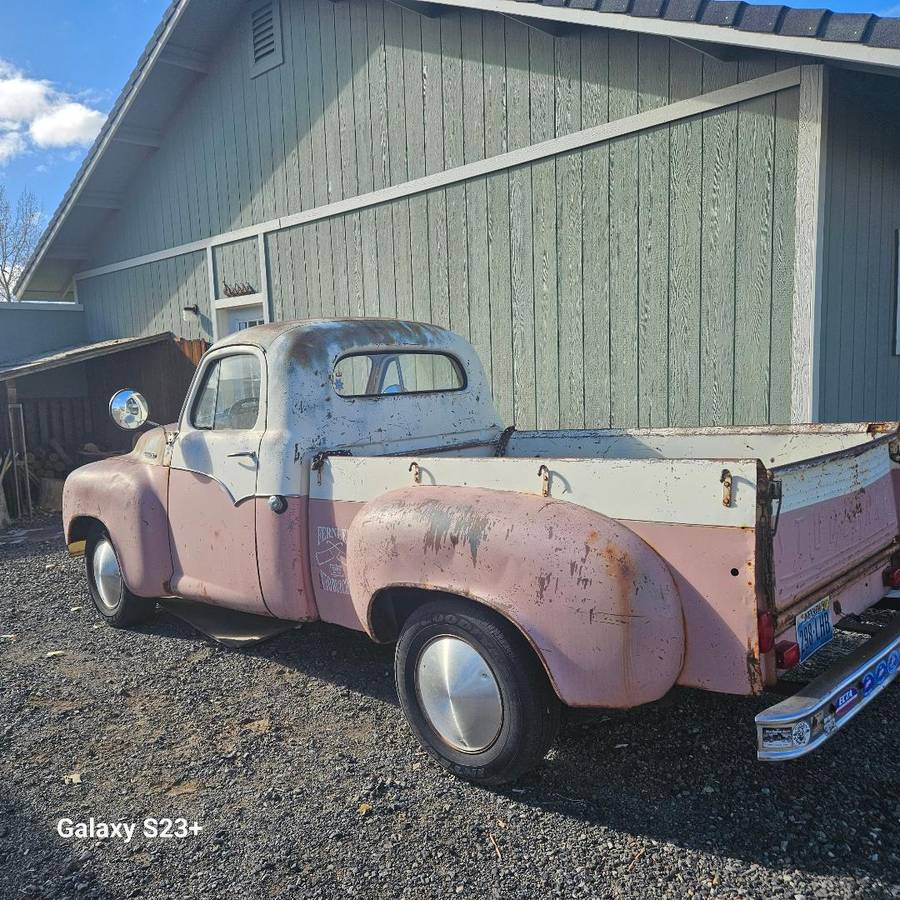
{"left": 0, "top": 59, "right": 106, "bottom": 166}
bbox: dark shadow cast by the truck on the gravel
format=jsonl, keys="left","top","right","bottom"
{"left": 241, "top": 624, "right": 900, "bottom": 880}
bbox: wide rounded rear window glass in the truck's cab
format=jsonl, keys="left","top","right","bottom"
{"left": 331, "top": 351, "right": 466, "bottom": 397}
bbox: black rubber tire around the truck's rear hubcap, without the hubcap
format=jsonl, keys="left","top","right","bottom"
{"left": 394, "top": 597, "right": 561, "bottom": 785}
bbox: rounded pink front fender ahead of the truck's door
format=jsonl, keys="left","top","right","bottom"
{"left": 62, "top": 454, "right": 172, "bottom": 597}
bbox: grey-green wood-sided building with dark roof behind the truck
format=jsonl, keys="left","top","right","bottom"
{"left": 10, "top": 0, "right": 900, "bottom": 428}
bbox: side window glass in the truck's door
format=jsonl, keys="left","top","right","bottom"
{"left": 193, "top": 354, "right": 260, "bottom": 431}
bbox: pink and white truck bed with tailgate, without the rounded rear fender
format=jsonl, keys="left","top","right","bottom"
{"left": 310, "top": 423, "right": 898, "bottom": 694}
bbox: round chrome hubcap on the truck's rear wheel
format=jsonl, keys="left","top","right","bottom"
{"left": 416, "top": 635, "right": 503, "bottom": 753}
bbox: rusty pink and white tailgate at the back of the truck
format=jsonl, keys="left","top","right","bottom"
{"left": 770, "top": 434, "right": 898, "bottom": 612}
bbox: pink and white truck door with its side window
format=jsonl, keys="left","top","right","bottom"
{"left": 169, "top": 346, "right": 266, "bottom": 613}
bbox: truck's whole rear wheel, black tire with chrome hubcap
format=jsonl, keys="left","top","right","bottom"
{"left": 395, "top": 598, "right": 560, "bottom": 785}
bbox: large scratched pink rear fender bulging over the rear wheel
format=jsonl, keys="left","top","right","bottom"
{"left": 347, "top": 486, "right": 684, "bottom": 708}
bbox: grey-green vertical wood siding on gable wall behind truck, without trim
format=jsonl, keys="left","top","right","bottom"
{"left": 79, "top": 0, "right": 798, "bottom": 427}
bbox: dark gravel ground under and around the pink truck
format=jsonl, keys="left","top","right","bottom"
{"left": 0, "top": 523, "right": 900, "bottom": 900}
